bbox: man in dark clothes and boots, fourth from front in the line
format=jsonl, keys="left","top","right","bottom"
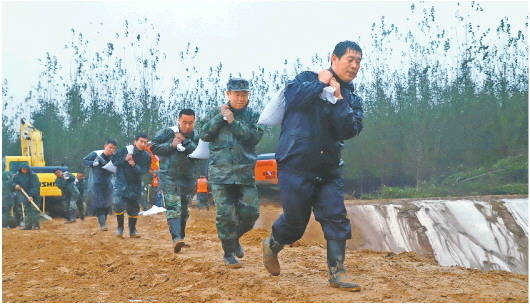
{"left": 112, "top": 135, "right": 151, "bottom": 238}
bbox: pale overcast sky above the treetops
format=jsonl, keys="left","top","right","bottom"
{"left": 2, "top": 1, "right": 528, "bottom": 101}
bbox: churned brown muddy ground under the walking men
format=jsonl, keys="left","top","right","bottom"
{"left": 2, "top": 206, "right": 528, "bottom": 303}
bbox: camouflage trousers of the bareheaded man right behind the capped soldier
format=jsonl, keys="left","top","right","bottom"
{"left": 161, "top": 182, "right": 194, "bottom": 221}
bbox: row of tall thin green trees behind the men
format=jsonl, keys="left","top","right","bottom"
{"left": 2, "top": 3, "right": 528, "bottom": 192}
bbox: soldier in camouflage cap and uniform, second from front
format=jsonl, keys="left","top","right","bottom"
{"left": 201, "top": 78, "right": 263, "bottom": 268}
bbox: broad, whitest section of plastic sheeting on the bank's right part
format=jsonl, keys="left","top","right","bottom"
{"left": 417, "top": 200, "right": 528, "bottom": 273}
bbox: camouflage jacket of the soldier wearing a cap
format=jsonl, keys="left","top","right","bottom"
{"left": 200, "top": 103, "right": 263, "bottom": 185}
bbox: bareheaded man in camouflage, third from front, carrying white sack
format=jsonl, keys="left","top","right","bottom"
{"left": 151, "top": 109, "right": 199, "bottom": 253}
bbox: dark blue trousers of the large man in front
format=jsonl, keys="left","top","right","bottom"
{"left": 272, "top": 170, "right": 351, "bottom": 244}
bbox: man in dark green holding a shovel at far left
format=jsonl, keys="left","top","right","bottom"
{"left": 13, "top": 164, "right": 40, "bottom": 230}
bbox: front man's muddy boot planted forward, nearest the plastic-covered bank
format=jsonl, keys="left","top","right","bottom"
{"left": 327, "top": 239, "right": 361, "bottom": 291}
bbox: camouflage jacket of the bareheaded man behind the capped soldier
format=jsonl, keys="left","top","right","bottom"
{"left": 151, "top": 128, "right": 199, "bottom": 183}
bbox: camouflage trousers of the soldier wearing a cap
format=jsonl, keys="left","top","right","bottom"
{"left": 212, "top": 184, "right": 259, "bottom": 240}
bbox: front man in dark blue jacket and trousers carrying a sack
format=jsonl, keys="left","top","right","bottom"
{"left": 263, "top": 41, "right": 363, "bottom": 291}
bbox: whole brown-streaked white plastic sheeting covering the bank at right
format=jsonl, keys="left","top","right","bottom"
{"left": 348, "top": 198, "right": 528, "bottom": 274}
